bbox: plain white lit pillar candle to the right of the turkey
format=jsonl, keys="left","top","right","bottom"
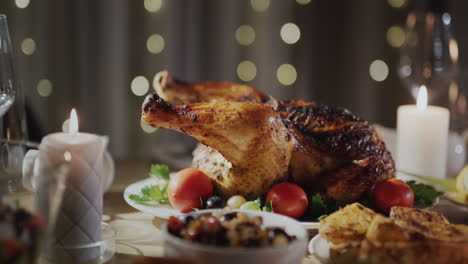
{"left": 396, "top": 85, "right": 450, "bottom": 178}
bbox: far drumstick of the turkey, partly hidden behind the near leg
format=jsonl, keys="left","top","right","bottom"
{"left": 153, "top": 71, "right": 268, "bottom": 104}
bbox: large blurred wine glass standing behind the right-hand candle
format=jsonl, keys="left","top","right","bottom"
{"left": 398, "top": 8, "right": 458, "bottom": 105}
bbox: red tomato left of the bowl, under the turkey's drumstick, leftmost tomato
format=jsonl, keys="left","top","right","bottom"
{"left": 167, "top": 168, "right": 213, "bottom": 213}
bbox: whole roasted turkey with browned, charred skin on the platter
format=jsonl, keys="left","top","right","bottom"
{"left": 142, "top": 71, "right": 395, "bottom": 203}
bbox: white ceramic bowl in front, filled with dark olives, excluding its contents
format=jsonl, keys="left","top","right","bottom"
{"left": 163, "top": 209, "right": 308, "bottom": 264}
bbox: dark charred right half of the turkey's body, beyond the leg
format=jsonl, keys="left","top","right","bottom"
{"left": 270, "top": 101, "right": 395, "bottom": 201}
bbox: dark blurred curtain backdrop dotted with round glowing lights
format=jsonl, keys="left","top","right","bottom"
{"left": 0, "top": 0, "right": 468, "bottom": 163}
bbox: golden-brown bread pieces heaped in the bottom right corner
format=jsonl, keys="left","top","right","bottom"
{"left": 319, "top": 207, "right": 468, "bottom": 264}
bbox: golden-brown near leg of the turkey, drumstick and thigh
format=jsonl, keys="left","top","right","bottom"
{"left": 143, "top": 94, "right": 292, "bottom": 198}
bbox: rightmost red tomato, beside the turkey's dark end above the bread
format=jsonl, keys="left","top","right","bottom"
{"left": 373, "top": 178, "right": 414, "bottom": 214}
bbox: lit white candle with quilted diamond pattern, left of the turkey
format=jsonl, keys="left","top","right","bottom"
{"left": 35, "top": 109, "right": 107, "bottom": 263}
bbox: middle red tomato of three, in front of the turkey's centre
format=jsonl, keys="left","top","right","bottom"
{"left": 265, "top": 182, "right": 309, "bottom": 218}
